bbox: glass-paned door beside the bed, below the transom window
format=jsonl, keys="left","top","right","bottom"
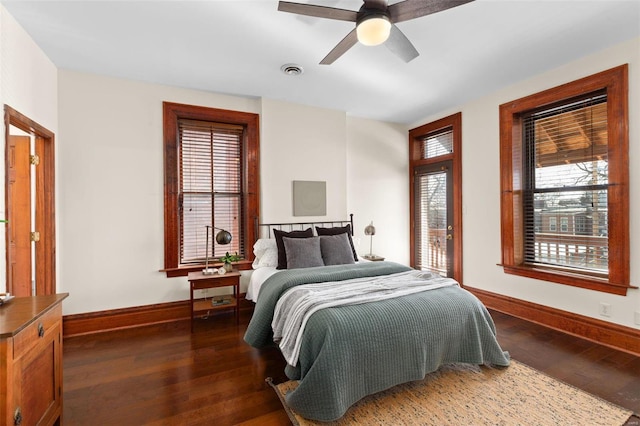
{"left": 413, "top": 161, "right": 455, "bottom": 277}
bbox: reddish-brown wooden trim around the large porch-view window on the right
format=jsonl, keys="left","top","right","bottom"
{"left": 500, "top": 64, "right": 634, "bottom": 295}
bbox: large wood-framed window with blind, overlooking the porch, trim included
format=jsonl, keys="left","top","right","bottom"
{"left": 500, "top": 65, "right": 630, "bottom": 294}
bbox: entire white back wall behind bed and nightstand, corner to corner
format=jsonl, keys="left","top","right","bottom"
{"left": 58, "top": 70, "right": 406, "bottom": 315}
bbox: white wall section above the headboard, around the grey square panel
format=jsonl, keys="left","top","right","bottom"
{"left": 260, "top": 99, "right": 347, "bottom": 223}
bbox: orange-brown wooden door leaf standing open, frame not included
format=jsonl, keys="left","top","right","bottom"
{"left": 7, "top": 136, "right": 32, "bottom": 296}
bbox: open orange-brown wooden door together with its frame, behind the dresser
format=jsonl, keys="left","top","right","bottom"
{"left": 4, "top": 105, "right": 56, "bottom": 296}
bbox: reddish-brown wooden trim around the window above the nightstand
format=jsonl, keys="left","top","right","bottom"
{"left": 162, "top": 102, "right": 260, "bottom": 277}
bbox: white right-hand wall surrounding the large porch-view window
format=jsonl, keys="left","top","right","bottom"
{"left": 413, "top": 39, "right": 640, "bottom": 328}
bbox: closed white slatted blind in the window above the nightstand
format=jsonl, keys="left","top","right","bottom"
{"left": 178, "top": 119, "right": 244, "bottom": 264}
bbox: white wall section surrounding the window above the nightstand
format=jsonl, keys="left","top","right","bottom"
{"left": 57, "top": 70, "right": 260, "bottom": 314}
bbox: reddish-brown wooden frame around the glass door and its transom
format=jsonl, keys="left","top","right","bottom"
{"left": 409, "top": 112, "right": 462, "bottom": 285}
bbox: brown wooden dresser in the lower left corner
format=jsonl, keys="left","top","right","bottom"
{"left": 0, "top": 293, "right": 68, "bottom": 426}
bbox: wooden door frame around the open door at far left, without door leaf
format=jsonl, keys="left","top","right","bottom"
{"left": 4, "top": 105, "right": 56, "bottom": 295}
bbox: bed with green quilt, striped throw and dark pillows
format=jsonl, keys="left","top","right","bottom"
{"left": 244, "top": 219, "right": 509, "bottom": 421}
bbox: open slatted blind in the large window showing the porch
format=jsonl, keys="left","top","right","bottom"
{"left": 523, "top": 93, "right": 608, "bottom": 273}
